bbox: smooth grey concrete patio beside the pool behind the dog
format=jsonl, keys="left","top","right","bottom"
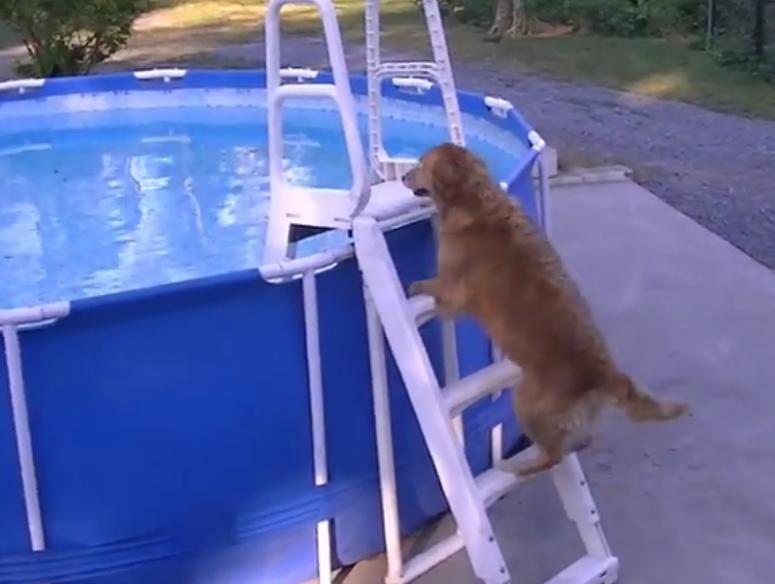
{"left": 339, "top": 180, "right": 775, "bottom": 584}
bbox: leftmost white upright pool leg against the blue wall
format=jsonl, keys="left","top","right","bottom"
{"left": 3, "top": 324, "right": 46, "bottom": 552}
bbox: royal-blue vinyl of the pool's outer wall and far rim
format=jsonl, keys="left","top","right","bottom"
{"left": 0, "top": 72, "right": 536, "bottom": 584}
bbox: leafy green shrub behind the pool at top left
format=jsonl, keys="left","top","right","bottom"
{"left": 0, "top": 0, "right": 146, "bottom": 77}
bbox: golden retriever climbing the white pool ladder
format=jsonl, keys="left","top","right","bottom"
{"left": 403, "top": 144, "right": 688, "bottom": 476}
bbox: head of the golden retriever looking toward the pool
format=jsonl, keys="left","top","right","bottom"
{"left": 402, "top": 143, "right": 490, "bottom": 209}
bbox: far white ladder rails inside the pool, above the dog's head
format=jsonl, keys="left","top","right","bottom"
{"left": 366, "top": 0, "right": 465, "bottom": 180}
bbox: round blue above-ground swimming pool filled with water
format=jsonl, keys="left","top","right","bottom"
{"left": 0, "top": 71, "right": 537, "bottom": 584}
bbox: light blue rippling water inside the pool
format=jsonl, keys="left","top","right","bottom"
{"left": 0, "top": 99, "right": 524, "bottom": 308}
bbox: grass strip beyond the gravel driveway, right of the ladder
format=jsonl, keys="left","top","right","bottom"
{"left": 440, "top": 27, "right": 775, "bottom": 119}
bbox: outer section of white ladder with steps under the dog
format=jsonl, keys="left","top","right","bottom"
{"left": 353, "top": 216, "right": 618, "bottom": 584}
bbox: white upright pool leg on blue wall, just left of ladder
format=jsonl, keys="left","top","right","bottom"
{"left": 302, "top": 271, "right": 331, "bottom": 584}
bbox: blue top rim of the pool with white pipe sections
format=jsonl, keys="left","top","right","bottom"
{"left": 0, "top": 69, "right": 546, "bottom": 329}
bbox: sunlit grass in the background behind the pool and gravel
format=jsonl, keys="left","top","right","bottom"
{"left": 136, "top": 0, "right": 775, "bottom": 119}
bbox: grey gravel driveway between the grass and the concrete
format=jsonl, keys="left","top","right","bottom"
{"left": 456, "top": 66, "right": 775, "bottom": 268}
